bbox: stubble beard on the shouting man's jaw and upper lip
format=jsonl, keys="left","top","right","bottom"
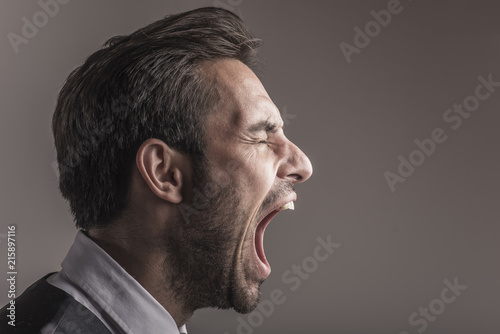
{"left": 164, "top": 159, "right": 293, "bottom": 314}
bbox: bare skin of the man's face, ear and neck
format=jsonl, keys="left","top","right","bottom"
{"left": 89, "top": 59, "right": 312, "bottom": 326}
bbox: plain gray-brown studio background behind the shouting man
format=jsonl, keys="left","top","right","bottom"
{"left": 0, "top": 0, "right": 500, "bottom": 334}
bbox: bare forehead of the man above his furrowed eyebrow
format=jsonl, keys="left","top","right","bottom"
{"left": 202, "top": 59, "right": 281, "bottom": 127}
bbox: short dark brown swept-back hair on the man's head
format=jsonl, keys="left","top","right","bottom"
{"left": 52, "top": 8, "right": 261, "bottom": 230}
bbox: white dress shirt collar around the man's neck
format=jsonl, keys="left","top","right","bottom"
{"left": 47, "top": 231, "right": 187, "bottom": 334}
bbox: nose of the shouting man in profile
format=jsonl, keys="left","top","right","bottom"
{"left": 278, "top": 141, "right": 313, "bottom": 183}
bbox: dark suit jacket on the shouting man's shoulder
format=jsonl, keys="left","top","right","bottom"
{"left": 0, "top": 273, "right": 111, "bottom": 334}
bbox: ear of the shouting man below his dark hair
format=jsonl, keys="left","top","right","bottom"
{"left": 136, "top": 138, "right": 191, "bottom": 204}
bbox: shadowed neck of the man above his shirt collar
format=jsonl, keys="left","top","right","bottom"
{"left": 88, "top": 222, "right": 194, "bottom": 327}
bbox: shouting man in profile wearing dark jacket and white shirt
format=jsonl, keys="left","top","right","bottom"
{"left": 1, "top": 8, "right": 312, "bottom": 333}
